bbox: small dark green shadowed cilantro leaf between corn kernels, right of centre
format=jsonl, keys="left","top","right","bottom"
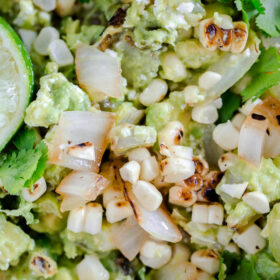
{"left": 217, "top": 91, "right": 241, "bottom": 124}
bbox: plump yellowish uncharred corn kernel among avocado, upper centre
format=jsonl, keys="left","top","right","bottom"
{"left": 161, "top": 52, "right": 188, "bottom": 82}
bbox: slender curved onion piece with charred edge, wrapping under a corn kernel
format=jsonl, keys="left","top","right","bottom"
{"left": 124, "top": 183, "right": 182, "bottom": 243}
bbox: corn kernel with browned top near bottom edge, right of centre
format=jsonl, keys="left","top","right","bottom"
{"left": 191, "top": 249, "right": 220, "bottom": 274}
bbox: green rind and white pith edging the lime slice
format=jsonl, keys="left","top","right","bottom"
{"left": 0, "top": 17, "right": 34, "bottom": 151}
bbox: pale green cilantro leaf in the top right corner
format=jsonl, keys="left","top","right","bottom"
{"left": 256, "top": 0, "right": 280, "bottom": 37}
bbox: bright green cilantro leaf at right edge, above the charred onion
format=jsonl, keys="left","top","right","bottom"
{"left": 241, "top": 47, "right": 280, "bottom": 101}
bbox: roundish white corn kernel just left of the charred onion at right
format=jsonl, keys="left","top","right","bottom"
{"left": 213, "top": 121, "right": 239, "bottom": 151}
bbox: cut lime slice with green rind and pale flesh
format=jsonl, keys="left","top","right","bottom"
{"left": 0, "top": 17, "right": 34, "bottom": 151}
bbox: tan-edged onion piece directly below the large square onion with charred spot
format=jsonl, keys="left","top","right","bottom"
{"left": 56, "top": 168, "right": 109, "bottom": 210}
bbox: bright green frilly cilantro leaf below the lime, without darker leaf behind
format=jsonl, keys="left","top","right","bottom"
{"left": 0, "top": 142, "right": 48, "bottom": 194}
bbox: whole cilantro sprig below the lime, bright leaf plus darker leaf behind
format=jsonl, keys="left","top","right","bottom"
{"left": 0, "top": 129, "right": 48, "bottom": 194}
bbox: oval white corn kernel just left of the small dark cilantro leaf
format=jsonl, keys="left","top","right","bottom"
{"left": 192, "top": 104, "right": 218, "bottom": 124}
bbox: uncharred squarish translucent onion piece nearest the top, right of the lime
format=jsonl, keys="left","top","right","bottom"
{"left": 75, "top": 45, "right": 122, "bottom": 98}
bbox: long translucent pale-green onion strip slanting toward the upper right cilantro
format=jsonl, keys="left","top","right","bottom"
{"left": 205, "top": 34, "right": 260, "bottom": 100}
